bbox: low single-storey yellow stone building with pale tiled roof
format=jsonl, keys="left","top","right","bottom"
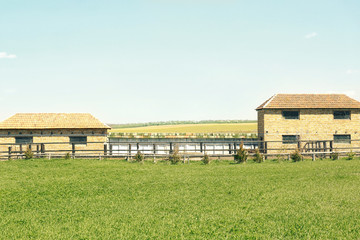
{"left": 0, "top": 113, "right": 110, "bottom": 157}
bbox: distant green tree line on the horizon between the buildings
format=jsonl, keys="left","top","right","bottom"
{"left": 109, "top": 120, "right": 257, "bottom": 128}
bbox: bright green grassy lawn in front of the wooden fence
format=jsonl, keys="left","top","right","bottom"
{"left": 0, "top": 159, "right": 360, "bottom": 239}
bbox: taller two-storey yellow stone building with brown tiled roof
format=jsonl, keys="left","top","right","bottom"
{"left": 256, "top": 94, "right": 360, "bottom": 153}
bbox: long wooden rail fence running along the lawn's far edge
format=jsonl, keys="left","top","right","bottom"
{"left": 0, "top": 138, "right": 360, "bottom": 161}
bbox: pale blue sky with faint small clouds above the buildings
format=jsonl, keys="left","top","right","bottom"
{"left": 0, "top": 0, "right": 360, "bottom": 123}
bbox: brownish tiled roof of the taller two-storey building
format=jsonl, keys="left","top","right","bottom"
{"left": 256, "top": 94, "right": 360, "bottom": 110}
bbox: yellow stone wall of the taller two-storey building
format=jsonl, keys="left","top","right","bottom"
{"left": 258, "top": 109, "right": 360, "bottom": 153}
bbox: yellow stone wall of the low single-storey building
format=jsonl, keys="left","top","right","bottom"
{"left": 0, "top": 129, "right": 107, "bottom": 155}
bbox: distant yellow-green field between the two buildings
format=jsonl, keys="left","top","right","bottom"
{"left": 111, "top": 123, "right": 257, "bottom": 133}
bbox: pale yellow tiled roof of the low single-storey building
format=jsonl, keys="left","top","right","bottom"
{"left": 0, "top": 113, "right": 110, "bottom": 129}
